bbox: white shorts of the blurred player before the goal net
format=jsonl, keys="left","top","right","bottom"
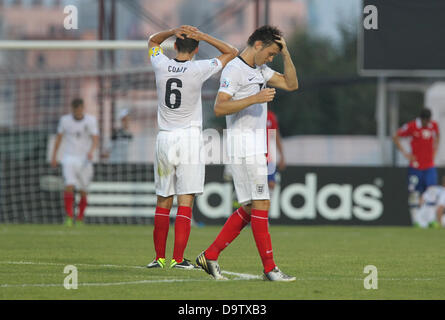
{"left": 62, "top": 157, "right": 94, "bottom": 191}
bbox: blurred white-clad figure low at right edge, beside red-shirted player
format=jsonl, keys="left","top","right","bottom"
{"left": 415, "top": 176, "right": 445, "bottom": 228}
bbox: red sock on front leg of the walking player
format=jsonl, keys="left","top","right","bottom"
{"left": 251, "top": 209, "right": 275, "bottom": 273}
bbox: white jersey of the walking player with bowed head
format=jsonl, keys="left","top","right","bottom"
{"left": 219, "top": 56, "right": 275, "bottom": 157}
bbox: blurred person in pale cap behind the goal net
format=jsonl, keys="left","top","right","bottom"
{"left": 102, "top": 109, "right": 133, "bottom": 163}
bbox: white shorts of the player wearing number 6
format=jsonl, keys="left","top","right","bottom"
{"left": 154, "top": 130, "right": 205, "bottom": 197}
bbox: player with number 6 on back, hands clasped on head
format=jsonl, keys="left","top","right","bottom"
{"left": 147, "top": 26, "right": 238, "bottom": 269}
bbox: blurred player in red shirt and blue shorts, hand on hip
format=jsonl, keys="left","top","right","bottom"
{"left": 393, "top": 108, "right": 439, "bottom": 225}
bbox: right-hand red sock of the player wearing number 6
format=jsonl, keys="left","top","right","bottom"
{"left": 173, "top": 206, "right": 192, "bottom": 263}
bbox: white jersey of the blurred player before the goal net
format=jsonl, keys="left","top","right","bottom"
{"left": 57, "top": 113, "right": 99, "bottom": 160}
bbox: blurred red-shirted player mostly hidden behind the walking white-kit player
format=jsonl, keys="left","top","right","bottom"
{"left": 266, "top": 103, "right": 286, "bottom": 198}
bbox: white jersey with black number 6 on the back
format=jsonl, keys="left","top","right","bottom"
{"left": 150, "top": 47, "right": 222, "bottom": 131}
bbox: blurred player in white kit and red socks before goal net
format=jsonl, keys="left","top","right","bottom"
{"left": 51, "top": 98, "right": 99, "bottom": 226}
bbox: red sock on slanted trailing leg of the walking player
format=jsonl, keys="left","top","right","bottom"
{"left": 204, "top": 207, "right": 250, "bottom": 260}
